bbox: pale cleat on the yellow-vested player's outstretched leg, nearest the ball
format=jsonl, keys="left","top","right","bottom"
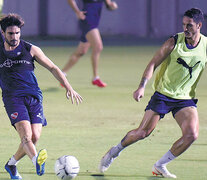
{"left": 99, "top": 147, "right": 119, "bottom": 173}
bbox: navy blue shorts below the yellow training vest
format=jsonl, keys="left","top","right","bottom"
{"left": 145, "top": 92, "right": 198, "bottom": 118}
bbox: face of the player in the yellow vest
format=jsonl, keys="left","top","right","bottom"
{"left": 183, "top": 16, "right": 201, "bottom": 39}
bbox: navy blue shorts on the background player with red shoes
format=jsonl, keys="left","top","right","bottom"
{"left": 80, "top": 2, "right": 103, "bottom": 42}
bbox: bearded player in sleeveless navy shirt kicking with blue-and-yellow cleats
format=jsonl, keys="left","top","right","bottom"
{"left": 0, "top": 14, "right": 82, "bottom": 179}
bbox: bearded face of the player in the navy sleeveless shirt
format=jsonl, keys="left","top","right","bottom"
{"left": 3, "top": 26, "right": 21, "bottom": 47}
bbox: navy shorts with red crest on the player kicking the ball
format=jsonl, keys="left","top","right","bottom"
{"left": 4, "top": 96, "right": 47, "bottom": 126}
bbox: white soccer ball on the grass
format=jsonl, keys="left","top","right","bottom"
{"left": 55, "top": 155, "right": 80, "bottom": 180}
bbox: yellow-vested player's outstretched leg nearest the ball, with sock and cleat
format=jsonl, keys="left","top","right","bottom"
{"left": 99, "top": 110, "right": 160, "bottom": 172}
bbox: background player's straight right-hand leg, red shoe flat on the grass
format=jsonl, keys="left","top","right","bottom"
{"left": 86, "top": 28, "right": 106, "bottom": 87}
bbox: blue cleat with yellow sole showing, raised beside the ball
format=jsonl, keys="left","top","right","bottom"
{"left": 36, "top": 149, "right": 47, "bottom": 176}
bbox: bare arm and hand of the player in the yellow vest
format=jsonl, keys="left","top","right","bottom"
{"left": 133, "top": 37, "right": 175, "bottom": 101}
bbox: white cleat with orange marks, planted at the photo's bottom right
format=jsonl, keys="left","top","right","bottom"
{"left": 152, "top": 164, "right": 177, "bottom": 178}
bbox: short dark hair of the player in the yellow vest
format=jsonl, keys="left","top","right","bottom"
{"left": 184, "top": 8, "right": 204, "bottom": 24}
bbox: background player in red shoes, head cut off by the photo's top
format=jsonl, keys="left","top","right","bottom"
{"left": 62, "top": 0, "right": 118, "bottom": 87}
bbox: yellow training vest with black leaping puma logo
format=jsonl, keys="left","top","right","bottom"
{"left": 153, "top": 32, "right": 207, "bottom": 99}
